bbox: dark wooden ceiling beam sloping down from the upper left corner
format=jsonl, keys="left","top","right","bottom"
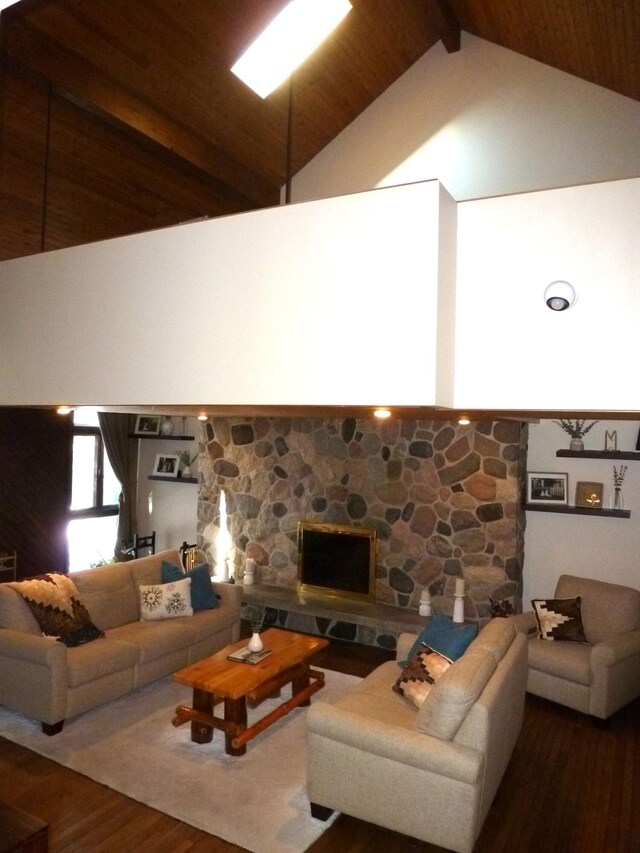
{"left": 4, "top": 18, "right": 280, "bottom": 207}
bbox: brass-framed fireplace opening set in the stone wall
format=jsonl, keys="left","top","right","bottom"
{"left": 298, "top": 521, "right": 376, "bottom": 601}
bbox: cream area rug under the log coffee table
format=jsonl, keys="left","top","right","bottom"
{"left": 0, "top": 671, "right": 358, "bottom": 853}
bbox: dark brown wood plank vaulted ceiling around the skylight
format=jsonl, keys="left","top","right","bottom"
{"left": 0, "top": 0, "right": 640, "bottom": 257}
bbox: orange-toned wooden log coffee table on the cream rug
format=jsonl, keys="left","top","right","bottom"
{"left": 172, "top": 628, "right": 329, "bottom": 755}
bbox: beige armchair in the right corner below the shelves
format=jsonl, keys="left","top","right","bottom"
{"left": 511, "top": 575, "right": 640, "bottom": 720}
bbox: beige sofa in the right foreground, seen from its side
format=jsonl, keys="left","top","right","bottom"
{"left": 307, "top": 619, "right": 527, "bottom": 853}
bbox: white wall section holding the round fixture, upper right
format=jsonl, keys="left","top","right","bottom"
{"left": 455, "top": 178, "right": 640, "bottom": 412}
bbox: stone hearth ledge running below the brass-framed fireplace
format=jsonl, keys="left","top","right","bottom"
{"left": 242, "top": 584, "right": 426, "bottom": 649}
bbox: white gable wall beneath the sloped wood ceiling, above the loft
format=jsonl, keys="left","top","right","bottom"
{"left": 292, "top": 33, "right": 640, "bottom": 201}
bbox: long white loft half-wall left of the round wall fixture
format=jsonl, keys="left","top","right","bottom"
{"left": 0, "top": 181, "right": 455, "bottom": 406}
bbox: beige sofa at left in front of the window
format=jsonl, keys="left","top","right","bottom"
{"left": 0, "top": 550, "right": 241, "bottom": 734}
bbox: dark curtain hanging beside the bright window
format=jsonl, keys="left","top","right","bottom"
{"left": 98, "top": 412, "right": 138, "bottom": 560}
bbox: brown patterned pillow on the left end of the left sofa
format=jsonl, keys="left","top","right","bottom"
{"left": 9, "top": 572, "right": 104, "bottom": 646}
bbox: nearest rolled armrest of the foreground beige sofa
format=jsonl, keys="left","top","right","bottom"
{"left": 307, "top": 702, "right": 483, "bottom": 784}
